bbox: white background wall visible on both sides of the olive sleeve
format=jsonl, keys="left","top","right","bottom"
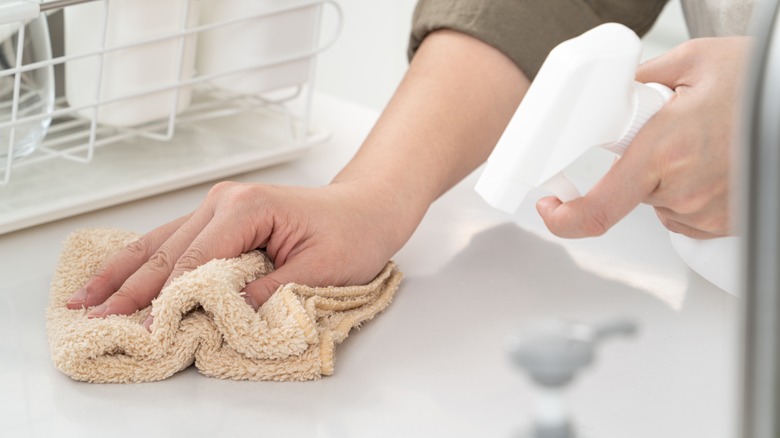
{"left": 317, "top": 0, "right": 688, "bottom": 109}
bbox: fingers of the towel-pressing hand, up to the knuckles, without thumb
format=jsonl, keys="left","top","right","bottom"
{"left": 78, "top": 184, "right": 272, "bottom": 328}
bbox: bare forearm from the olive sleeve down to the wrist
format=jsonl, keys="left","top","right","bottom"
{"left": 334, "top": 30, "right": 529, "bottom": 225}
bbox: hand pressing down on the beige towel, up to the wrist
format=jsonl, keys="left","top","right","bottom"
{"left": 67, "top": 183, "right": 416, "bottom": 327}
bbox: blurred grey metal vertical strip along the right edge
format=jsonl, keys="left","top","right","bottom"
{"left": 740, "top": 1, "right": 780, "bottom": 438}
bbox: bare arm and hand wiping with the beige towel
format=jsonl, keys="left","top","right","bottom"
{"left": 68, "top": 31, "right": 528, "bottom": 317}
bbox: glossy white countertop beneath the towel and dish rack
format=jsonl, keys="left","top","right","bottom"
{"left": 0, "top": 95, "right": 739, "bottom": 438}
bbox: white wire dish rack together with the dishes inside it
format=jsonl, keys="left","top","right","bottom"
{"left": 0, "top": 0, "right": 342, "bottom": 234}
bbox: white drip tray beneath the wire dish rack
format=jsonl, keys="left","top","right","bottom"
{"left": 0, "top": 107, "right": 329, "bottom": 234}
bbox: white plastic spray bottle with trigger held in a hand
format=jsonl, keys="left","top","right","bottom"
{"left": 476, "top": 23, "right": 740, "bottom": 294}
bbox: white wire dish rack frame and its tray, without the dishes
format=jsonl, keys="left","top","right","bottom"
{"left": 0, "top": 0, "right": 342, "bottom": 234}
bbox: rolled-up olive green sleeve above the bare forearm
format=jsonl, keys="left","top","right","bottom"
{"left": 409, "top": 0, "right": 666, "bottom": 79}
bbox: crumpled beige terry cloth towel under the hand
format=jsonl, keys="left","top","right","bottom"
{"left": 46, "top": 229, "right": 402, "bottom": 383}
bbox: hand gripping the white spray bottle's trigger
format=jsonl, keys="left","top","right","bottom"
{"left": 537, "top": 37, "right": 750, "bottom": 239}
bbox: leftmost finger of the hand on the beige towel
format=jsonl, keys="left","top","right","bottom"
{"left": 66, "top": 216, "right": 189, "bottom": 309}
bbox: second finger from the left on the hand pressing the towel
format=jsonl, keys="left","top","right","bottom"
{"left": 87, "top": 212, "right": 211, "bottom": 318}
